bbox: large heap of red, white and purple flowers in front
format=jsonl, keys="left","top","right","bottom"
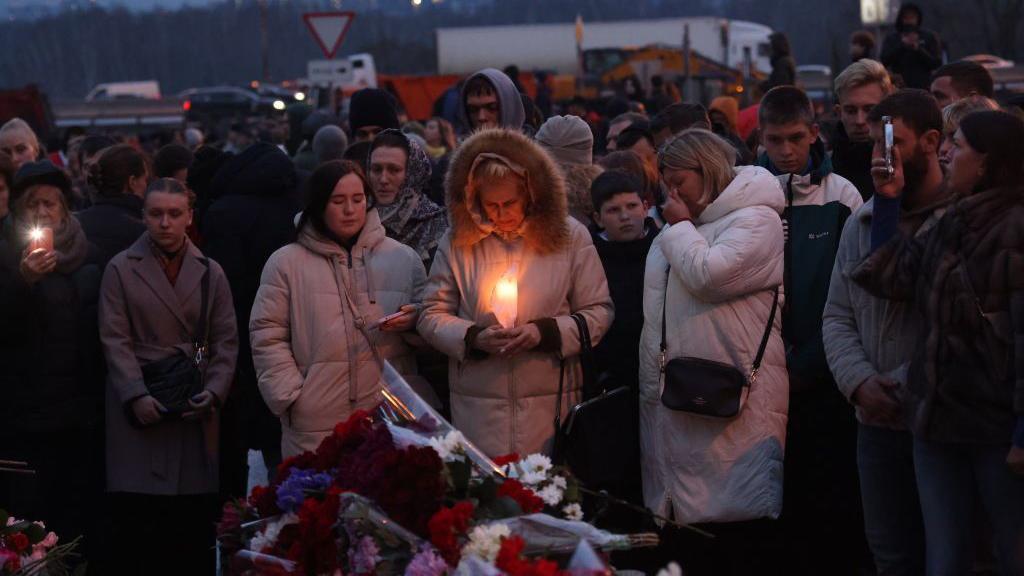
{"left": 218, "top": 403, "right": 629, "bottom": 576}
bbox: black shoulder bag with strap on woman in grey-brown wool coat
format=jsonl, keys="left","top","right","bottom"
{"left": 133, "top": 266, "right": 210, "bottom": 425}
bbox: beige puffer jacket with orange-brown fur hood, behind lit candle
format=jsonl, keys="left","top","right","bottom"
{"left": 418, "top": 129, "right": 613, "bottom": 456}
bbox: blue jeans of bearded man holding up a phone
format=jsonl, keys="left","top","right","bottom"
{"left": 857, "top": 423, "right": 925, "bottom": 576}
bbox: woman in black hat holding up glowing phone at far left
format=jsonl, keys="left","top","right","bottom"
{"left": 0, "top": 160, "right": 102, "bottom": 565}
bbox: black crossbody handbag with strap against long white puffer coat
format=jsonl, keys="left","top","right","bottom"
{"left": 659, "top": 270, "right": 778, "bottom": 418}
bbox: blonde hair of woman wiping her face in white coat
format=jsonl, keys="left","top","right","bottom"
{"left": 657, "top": 128, "right": 736, "bottom": 206}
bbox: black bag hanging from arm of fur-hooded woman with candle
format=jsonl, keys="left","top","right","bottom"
{"left": 555, "top": 315, "right": 639, "bottom": 487}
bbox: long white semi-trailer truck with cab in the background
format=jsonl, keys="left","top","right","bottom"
{"left": 436, "top": 16, "right": 772, "bottom": 75}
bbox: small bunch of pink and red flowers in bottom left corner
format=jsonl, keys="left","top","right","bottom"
{"left": 0, "top": 509, "right": 78, "bottom": 576}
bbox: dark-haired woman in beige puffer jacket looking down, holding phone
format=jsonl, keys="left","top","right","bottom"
{"left": 249, "top": 160, "right": 426, "bottom": 458}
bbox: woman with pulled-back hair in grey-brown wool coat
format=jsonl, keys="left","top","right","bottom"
{"left": 99, "top": 178, "right": 239, "bottom": 574}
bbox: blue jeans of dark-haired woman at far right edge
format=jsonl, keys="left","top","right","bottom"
{"left": 913, "top": 439, "right": 1024, "bottom": 576}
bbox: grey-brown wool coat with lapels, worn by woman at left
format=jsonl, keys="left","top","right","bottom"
{"left": 99, "top": 233, "right": 239, "bottom": 495}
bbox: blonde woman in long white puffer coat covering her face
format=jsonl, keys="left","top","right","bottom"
{"left": 640, "top": 130, "right": 788, "bottom": 574}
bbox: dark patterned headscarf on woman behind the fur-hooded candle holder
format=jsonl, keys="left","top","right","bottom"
{"left": 368, "top": 130, "right": 447, "bottom": 261}
